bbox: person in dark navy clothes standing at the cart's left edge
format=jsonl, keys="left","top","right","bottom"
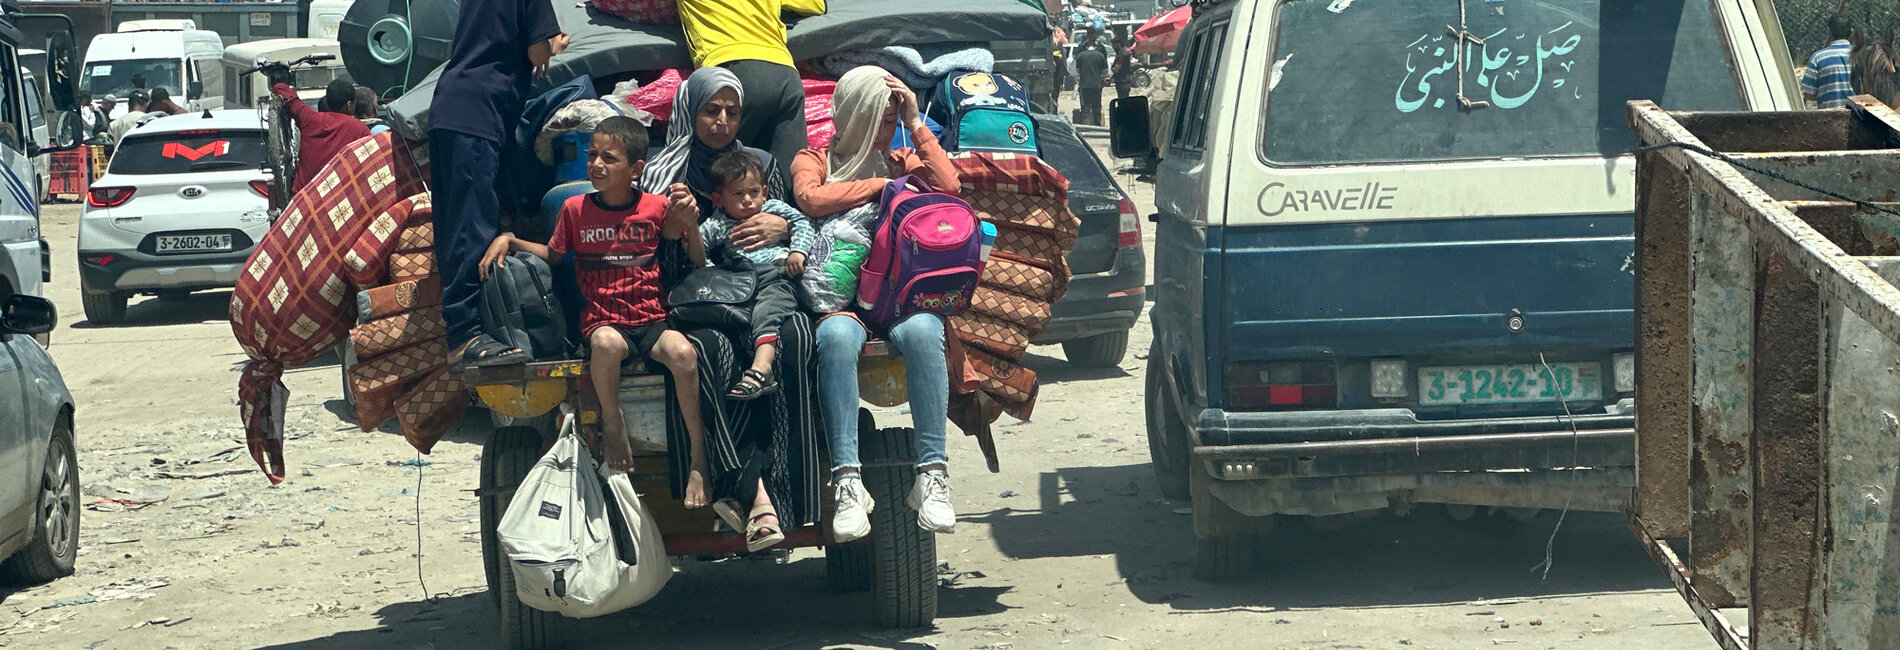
{"left": 433, "top": 0, "right": 568, "bottom": 367}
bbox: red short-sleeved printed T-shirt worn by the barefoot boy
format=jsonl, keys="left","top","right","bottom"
{"left": 547, "top": 192, "right": 667, "bottom": 335}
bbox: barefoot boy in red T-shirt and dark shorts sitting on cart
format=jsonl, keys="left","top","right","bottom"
{"left": 481, "top": 116, "right": 707, "bottom": 507}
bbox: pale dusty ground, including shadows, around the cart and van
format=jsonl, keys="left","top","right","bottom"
{"left": 0, "top": 129, "right": 1712, "bottom": 650}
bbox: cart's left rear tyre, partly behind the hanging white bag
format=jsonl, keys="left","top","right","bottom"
{"left": 479, "top": 426, "right": 551, "bottom": 650}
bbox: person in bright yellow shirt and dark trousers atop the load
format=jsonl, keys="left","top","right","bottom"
{"left": 680, "top": 0, "right": 825, "bottom": 185}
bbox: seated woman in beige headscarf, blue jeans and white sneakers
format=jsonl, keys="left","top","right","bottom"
{"left": 792, "top": 67, "right": 960, "bottom": 542}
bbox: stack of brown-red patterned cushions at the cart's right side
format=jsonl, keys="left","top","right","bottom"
{"left": 950, "top": 152, "right": 1081, "bottom": 471}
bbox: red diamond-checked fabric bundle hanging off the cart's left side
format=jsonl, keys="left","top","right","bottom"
{"left": 230, "top": 131, "right": 422, "bottom": 483}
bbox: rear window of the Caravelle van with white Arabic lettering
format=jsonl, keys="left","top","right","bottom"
{"left": 1262, "top": 0, "right": 1740, "bottom": 165}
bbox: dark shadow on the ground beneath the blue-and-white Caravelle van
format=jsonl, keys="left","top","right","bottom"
{"left": 965, "top": 466, "right": 1670, "bottom": 610}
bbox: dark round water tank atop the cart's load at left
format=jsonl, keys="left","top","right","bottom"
{"left": 336, "top": 0, "right": 462, "bottom": 97}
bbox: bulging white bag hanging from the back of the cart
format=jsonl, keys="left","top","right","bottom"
{"left": 496, "top": 418, "right": 673, "bottom": 618}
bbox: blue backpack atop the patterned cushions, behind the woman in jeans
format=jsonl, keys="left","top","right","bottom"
{"left": 935, "top": 72, "right": 1041, "bottom": 156}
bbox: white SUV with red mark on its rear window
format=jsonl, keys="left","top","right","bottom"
{"left": 80, "top": 110, "right": 270, "bottom": 325}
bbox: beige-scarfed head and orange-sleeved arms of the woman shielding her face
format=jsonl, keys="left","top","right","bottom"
{"left": 792, "top": 65, "right": 958, "bottom": 217}
